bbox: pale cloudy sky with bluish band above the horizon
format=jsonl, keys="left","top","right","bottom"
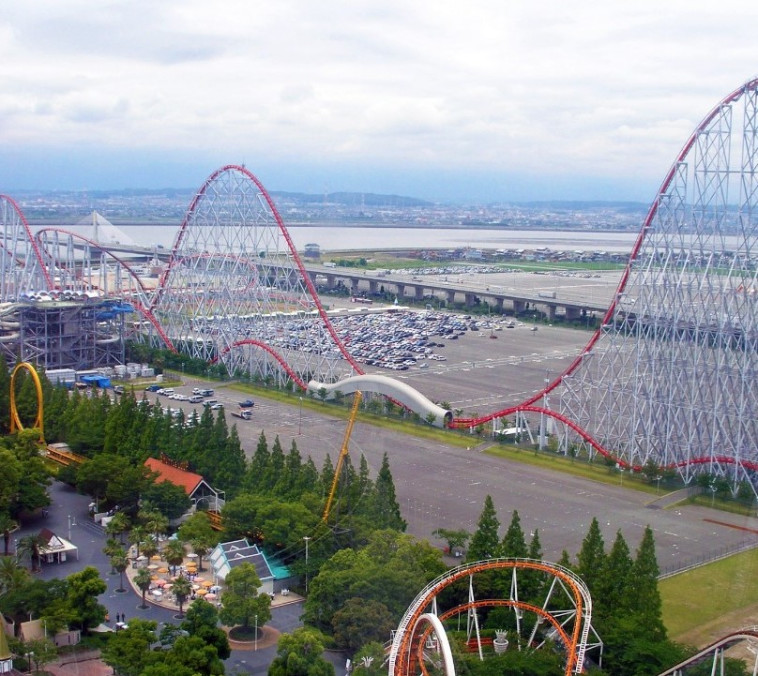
{"left": 0, "top": 0, "right": 758, "bottom": 203}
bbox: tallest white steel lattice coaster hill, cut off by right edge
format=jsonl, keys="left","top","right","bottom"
{"left": 560, "top": 80, "right": 758, "bottom": 490}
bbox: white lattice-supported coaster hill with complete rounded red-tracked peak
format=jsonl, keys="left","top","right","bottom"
{"left": 151, "top": 165, "right": 357, "bottom": 388}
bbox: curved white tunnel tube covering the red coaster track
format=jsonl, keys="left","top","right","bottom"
{"left": 308, "top": 374, "right": 453, "bottom": 427}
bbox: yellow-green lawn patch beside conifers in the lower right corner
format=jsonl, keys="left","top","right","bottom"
{"left": 658, "top": 549, "right": 758, "bottom": 640}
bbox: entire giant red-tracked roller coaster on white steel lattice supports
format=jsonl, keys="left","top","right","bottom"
{"left": 0, "top": 80, "right": 758, "bottom": 495}
